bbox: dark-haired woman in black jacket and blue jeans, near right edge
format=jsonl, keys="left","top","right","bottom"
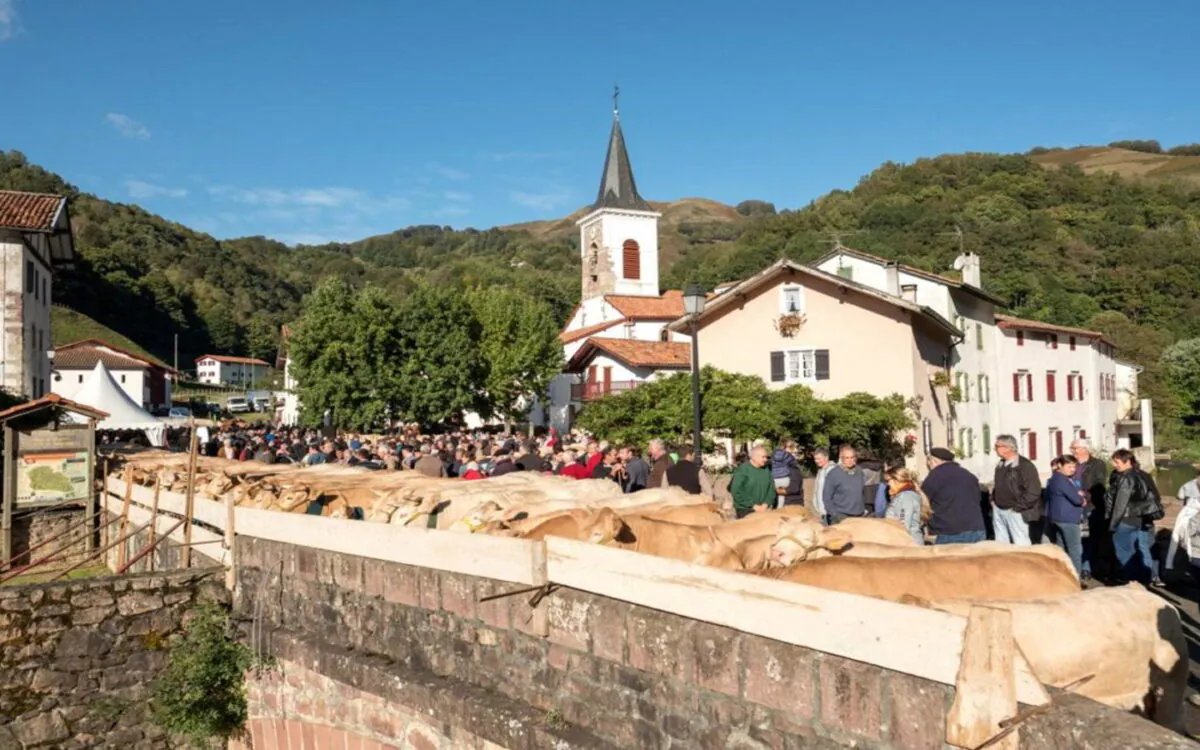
{"left": 1104, "top": 449, "right": 1163, "bottom": 584}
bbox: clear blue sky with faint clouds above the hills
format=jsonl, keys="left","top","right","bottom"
{"left": 0, "top": 0, "right": 1200, "bottom": 242}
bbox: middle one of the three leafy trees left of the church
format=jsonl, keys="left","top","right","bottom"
{"left": 395, "top": 284, "right": 487, "bottom": 425}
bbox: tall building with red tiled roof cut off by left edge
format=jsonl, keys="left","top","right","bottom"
{"left": 0, "top": 191, "right": 74, "bottom": 398}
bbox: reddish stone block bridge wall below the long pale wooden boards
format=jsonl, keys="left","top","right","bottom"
{"left": 235, "top": 538, "right": 953, "bottom": 750}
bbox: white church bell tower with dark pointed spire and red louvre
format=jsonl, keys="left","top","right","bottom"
{"left": 576, "top": 90, "right": 661, "bottom": 299}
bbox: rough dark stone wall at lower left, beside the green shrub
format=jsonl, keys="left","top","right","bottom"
{"left": 0, "top": 569, "right": 226, "bottom": 750}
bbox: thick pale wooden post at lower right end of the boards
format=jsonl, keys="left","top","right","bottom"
{"left": 946, "top": 606, "right": 1019, "bottom": 750}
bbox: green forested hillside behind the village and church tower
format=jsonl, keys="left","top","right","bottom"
{"left": 0, "top": 144, "right": 1200, "bottom": 427}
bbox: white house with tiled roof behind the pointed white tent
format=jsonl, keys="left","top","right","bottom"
{"left": 50, "top": 338, "right": 176, "bottom": 412}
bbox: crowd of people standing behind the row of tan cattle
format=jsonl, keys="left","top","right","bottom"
{"left": 145, "top": 422, "right": 1176, "bottom": 584}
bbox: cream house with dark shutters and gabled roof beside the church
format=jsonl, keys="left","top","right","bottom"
{"left": 670, "top": 260, "right": 960, "bottom": 466}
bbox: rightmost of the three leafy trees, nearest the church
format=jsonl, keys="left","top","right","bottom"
{"left": 468, "top": 287, "right": 563, "bottom": 420}
